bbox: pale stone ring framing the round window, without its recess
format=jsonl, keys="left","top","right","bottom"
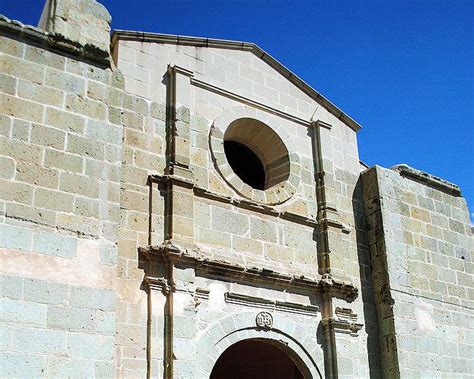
{"left": 209, "top": 106, "right": 300, "bottom": 205}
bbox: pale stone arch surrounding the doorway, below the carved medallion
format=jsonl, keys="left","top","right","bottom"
{"left": 195, "top": 311, "right": 323, "bottom": 378}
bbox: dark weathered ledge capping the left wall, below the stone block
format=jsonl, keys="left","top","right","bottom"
{"left": 0, "top": 15, "right": 111, "bottom": 68}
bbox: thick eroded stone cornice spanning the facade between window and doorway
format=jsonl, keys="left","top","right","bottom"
{"left": 139, "top": 241, "right": 359, "bottom": 302}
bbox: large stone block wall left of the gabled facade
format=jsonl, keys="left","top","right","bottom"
{"left": 0, "top": 8, "right": 123, "bottom": 377}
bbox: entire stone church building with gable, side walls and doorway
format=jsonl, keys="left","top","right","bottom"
{"left": 0, "top": 0, "right": 474, "bottom": 378}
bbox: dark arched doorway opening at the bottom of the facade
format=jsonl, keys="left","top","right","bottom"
{"left": 211, "top": 339, "right": 304, "bottom": 379}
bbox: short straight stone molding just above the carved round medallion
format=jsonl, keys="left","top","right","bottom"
{"left": 224, "top": 292, "right": 319, "bottom": 316}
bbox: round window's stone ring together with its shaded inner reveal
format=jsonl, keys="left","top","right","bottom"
{"left": 209, "top": 106, "right": 300, "bottom": 204}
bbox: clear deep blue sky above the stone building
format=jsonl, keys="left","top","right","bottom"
{"left": 0, "top": 0, "right": 474, "bottom": 218}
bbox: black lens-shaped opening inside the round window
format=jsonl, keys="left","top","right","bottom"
{"left": 224, "top": 141, "right": 265, "bottom": 190}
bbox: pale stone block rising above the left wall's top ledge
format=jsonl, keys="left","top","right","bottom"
{"left": 38, "top": 0, "right": 112, "bottom": 53}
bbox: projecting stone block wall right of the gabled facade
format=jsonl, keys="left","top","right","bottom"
{"left": 362, "top": 166, "right": 473, "bottom": 377}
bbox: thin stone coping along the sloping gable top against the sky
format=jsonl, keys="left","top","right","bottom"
{"left": 112, "top": 30, "right": 362, "bottom": 132}
